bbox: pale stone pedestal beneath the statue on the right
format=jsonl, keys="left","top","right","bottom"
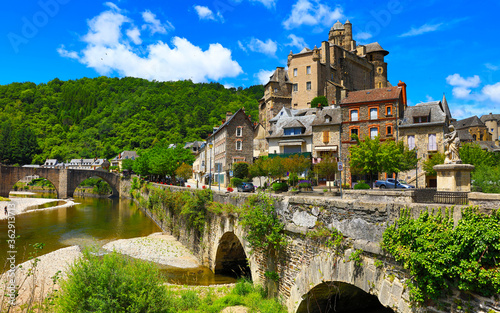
{"left": 434, "top": 164, "right": 474, "bottom": 192}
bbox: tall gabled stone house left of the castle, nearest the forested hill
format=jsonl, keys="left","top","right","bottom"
{"left": 204, "top": 109, "right": 254, "bottom": 187}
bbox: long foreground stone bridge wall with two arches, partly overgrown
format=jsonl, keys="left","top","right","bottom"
{"left": 134, "top": 182, "right": 500, "bottom": 313}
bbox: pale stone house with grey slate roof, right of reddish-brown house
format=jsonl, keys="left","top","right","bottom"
{"left": 399, "top": 96, "right": 452, "bottom": 188}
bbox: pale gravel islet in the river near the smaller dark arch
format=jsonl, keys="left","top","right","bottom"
{"left": 103, "top": 233, "right": 200, "bottom": 268}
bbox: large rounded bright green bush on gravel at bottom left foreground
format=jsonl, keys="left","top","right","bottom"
{"left": 56, "top": 249, "right": 169, "bottom": 312}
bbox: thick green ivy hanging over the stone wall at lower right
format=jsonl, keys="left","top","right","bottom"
{"left": 383, "top": 207, "right": 500, "bottom": 303}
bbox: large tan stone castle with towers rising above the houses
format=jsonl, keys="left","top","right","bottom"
{"left": 259, "top": 21, "right": 391, "bottom": 130}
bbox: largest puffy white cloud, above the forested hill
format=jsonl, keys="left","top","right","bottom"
{"left": 57, "top": 5, "right": 242, "bottom": 82}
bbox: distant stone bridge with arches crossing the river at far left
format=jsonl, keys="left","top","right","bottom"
{"left": 0, "top": 165, "right": 120, "bottom": 199}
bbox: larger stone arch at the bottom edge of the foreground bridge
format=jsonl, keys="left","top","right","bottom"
{"left": 286, "top": 249, "right": 410, "bottom": 313}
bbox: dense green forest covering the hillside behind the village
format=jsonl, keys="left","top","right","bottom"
{"left": 0, "top": 77, "right": 264, "bottom": 164}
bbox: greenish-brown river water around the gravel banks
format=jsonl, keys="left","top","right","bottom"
{"left": 0, "top": 194, "right": 235, "bottom": 285}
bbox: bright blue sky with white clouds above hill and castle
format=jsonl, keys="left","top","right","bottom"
{"left": 0, "top": 0, "right": 500, "bottom": 118}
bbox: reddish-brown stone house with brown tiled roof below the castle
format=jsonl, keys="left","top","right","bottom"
{"left": 340, "top": 81, "right": 407, "bottom": 185}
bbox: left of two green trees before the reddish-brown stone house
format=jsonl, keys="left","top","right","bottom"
{"left": 349, "top": 136, "right": 384, "bottom": 186}
